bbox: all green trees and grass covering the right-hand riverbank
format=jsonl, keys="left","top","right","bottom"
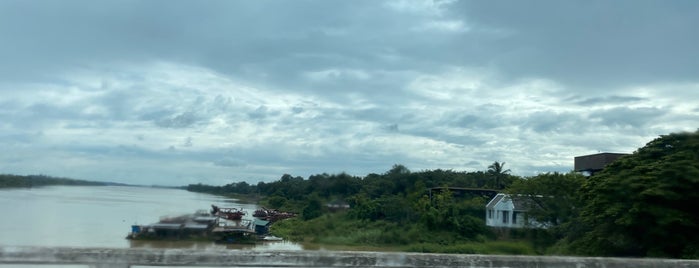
{"left": 188, "top": 131, "right": 699, "bottom": 258}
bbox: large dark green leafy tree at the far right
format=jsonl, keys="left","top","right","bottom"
{"left": 569, "top": 131, "right": 699, "bottom": 258}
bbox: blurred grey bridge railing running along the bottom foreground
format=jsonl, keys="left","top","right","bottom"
{"left": 0, "top": 246, "right": 699, "bottom": 268}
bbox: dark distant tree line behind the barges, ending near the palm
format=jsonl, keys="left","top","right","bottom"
{"left": 185, "top": 162, "right": 519, "bottom": 200}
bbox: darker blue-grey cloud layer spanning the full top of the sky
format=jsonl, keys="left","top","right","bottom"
{"left": 0, "top": 1, "right": 699, "bottom": 95}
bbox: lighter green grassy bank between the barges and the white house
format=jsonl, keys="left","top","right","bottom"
{"left": 271, "top": 213, "right": 537, "bottom": 255}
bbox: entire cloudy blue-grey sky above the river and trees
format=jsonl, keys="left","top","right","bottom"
{"left": 0, "top": 0, "right": 699, "bottom": 185}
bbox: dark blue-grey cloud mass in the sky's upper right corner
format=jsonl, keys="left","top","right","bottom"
{"left": 450, "top": 1, "right": 699, "bottom": 92}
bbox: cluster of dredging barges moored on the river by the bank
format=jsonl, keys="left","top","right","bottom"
{"left": 126, "top": 205, "right": 296, "bottom": 243}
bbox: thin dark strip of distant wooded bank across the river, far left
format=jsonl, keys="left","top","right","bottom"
{"left": 0, "top": 174, "right": 112, "bottom": 188}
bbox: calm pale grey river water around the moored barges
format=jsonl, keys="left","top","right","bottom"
{"left": 0, "top": 186, "right": 302, "bottom": 250}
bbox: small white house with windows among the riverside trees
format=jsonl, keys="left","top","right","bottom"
{"left": 485, "top": 194, "right": 543, "bottom": 228}
